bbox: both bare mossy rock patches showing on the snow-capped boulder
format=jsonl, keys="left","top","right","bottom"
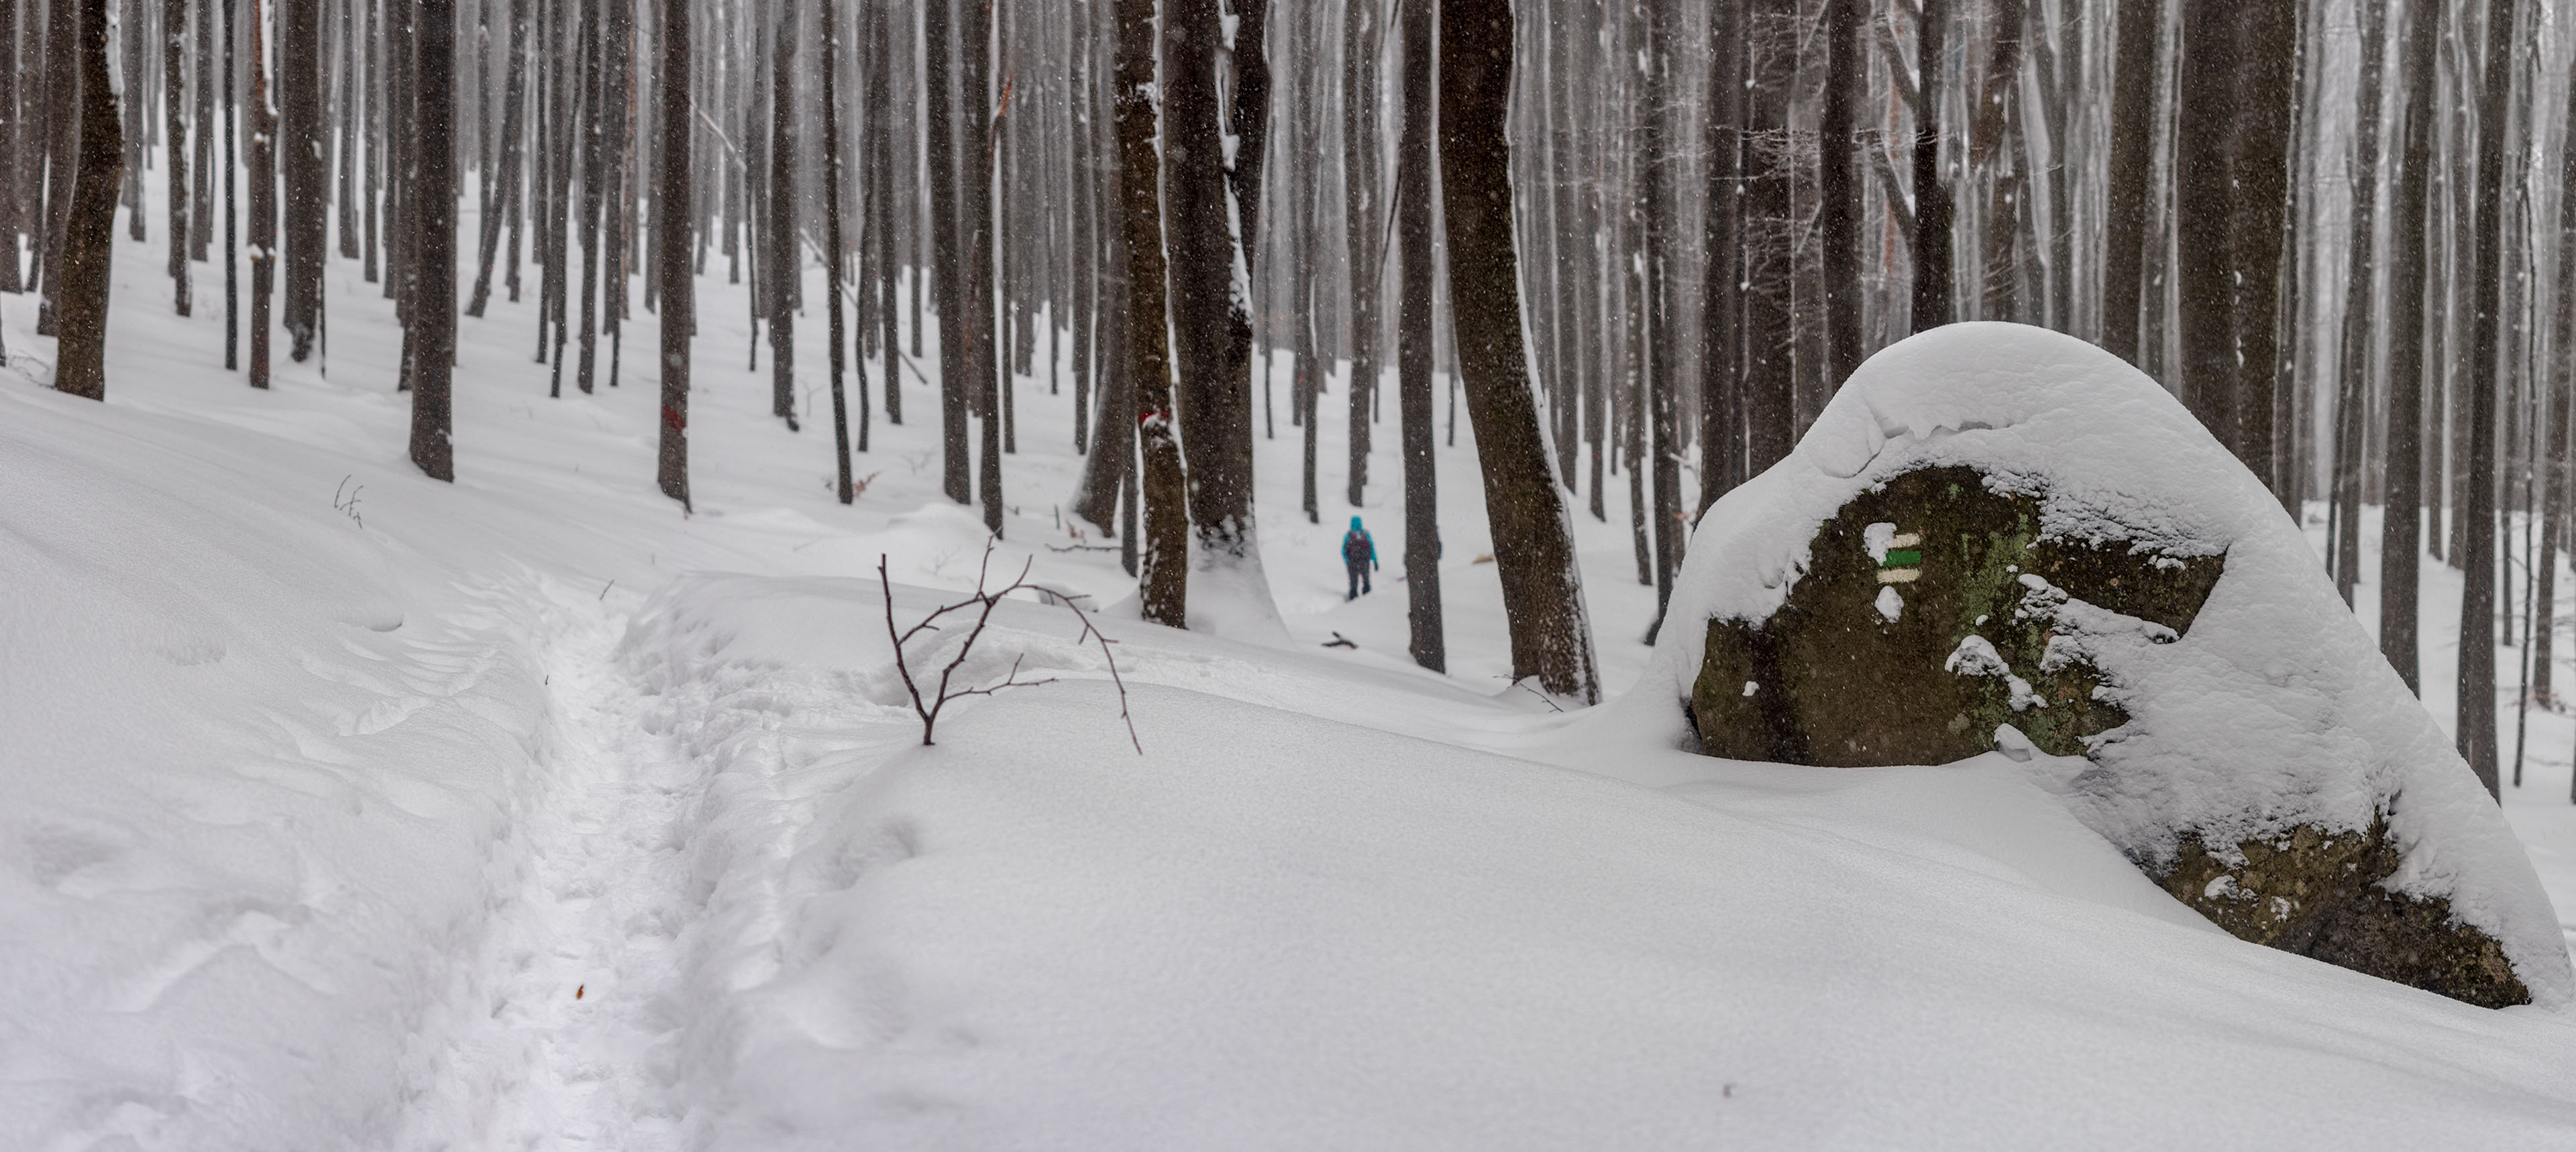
{"left": 1690, "top": 467, "right": 2530, "bottom": 1008}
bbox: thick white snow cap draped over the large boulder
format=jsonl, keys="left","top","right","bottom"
{"left": 1615, "top": 325, "right": 2571, "bottom": 1002}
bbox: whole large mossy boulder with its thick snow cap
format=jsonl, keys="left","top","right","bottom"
{"left": 1641, "top": 325, "right": 2571, "bottom": 1005}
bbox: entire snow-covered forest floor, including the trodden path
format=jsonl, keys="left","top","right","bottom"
{"left": 0, "top": 193, "right": 2576, "bottom": 1149}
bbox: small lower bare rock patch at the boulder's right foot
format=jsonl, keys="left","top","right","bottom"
{"left": 2149, "top": 817, "right": 2532, "bottom": 1008}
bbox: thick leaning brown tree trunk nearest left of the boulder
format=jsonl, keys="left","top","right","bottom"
{"left": 1442, "top": 0, "right": 1597, "bottom": 703}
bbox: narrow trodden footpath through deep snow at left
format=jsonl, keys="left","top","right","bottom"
{"left": 399, "top": 580, "right": 703, "bottom": 1152}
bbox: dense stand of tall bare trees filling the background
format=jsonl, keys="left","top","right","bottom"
{"left": 0, "top": 0, "right": 2576, "bottom": 791}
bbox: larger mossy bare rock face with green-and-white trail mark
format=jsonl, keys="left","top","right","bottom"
{"left": 1690, "top": 467, "right": 2223, "bottom": 768}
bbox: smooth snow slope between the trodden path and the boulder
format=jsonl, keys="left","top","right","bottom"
{"left": 602, "top": 577, "right": 2576, "bottom": 1147}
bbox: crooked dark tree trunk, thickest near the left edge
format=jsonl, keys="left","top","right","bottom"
{"left": 46, "top": 0, "right": 126, "bottom": 400}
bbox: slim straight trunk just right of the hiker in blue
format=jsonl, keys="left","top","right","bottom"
{"left": 1396, "top": 0, "right": 1448, "bottom": 673}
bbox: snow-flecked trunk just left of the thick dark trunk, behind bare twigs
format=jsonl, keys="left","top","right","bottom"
{"left": 1116, "top": 0, "right": 1190, "bottom": 629}
